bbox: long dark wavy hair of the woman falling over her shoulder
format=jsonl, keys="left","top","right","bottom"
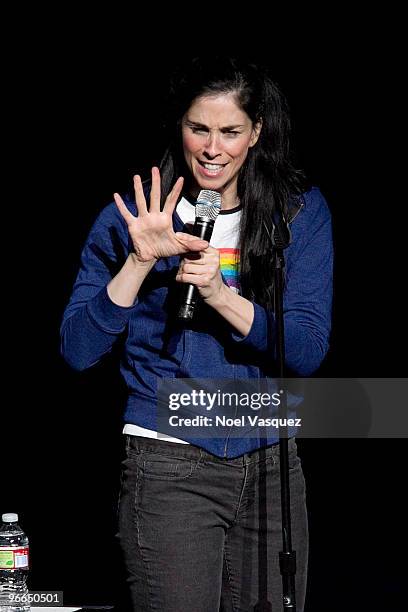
{"left": 160, "top": 57, "right": 305, "bottom": 308}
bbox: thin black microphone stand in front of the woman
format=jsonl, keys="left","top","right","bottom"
{"left": 254, "top": 218, "right": 296, "bottom": 612}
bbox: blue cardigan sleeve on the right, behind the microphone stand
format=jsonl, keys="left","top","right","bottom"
{"left": 232, "top": 188, "right": 333, "bottom": 376}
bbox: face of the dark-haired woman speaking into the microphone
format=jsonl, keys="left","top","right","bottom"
{"left": 182, "top": 93, "right": 261, "bottom": 208}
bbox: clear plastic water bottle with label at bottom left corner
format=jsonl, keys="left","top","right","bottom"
{"left": 0, "top": 513, "right": 30, "bottom": 612}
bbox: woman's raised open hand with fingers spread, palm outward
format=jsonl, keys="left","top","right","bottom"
{"left": 114, "top": 168, "right": 208, "bottom": 263}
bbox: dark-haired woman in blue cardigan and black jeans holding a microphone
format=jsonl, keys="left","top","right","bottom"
{"left": 62, "top": 59, "right": 332, "bottom": 612}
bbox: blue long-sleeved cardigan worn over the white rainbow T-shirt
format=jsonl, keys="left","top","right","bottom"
{"left": 61, "top": 188, "right": 333, "bottom": 458}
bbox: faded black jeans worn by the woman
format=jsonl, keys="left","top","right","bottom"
{"left": 118, "top": 436, "right": 308, "bottom": 612}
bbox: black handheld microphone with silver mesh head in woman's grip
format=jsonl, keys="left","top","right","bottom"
{"left": 178, "top": 189, "right": 221, "bottom": 321}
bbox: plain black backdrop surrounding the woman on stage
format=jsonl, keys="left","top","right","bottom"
{"left": 0, "top": 10, "right": 406, "bottom": 612}
